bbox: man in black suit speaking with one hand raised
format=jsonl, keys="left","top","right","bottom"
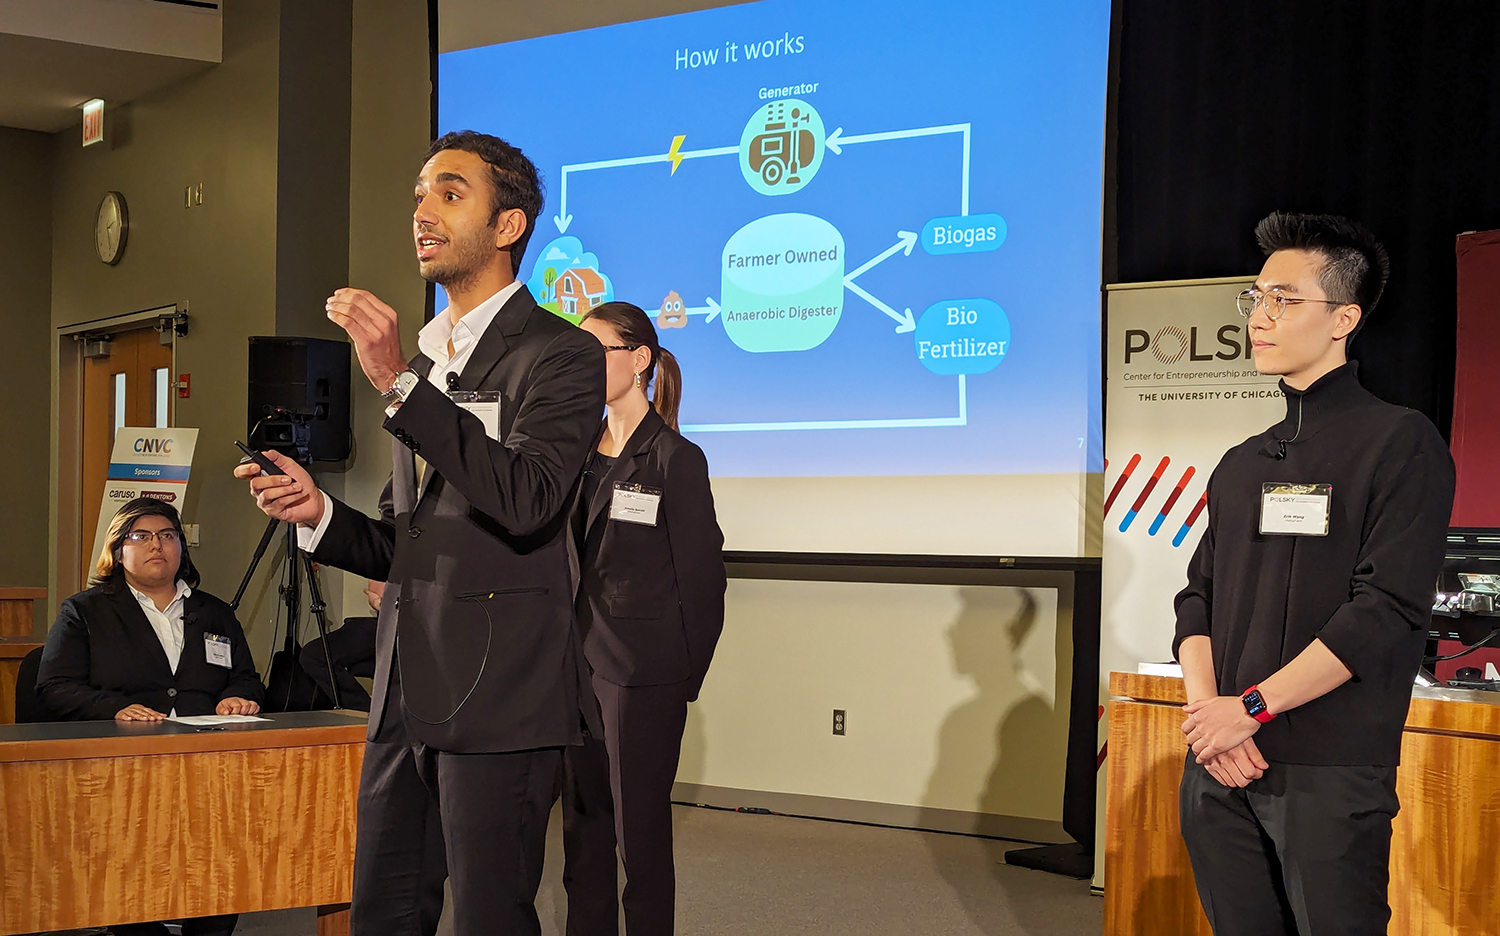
{"left": 236, "top": 132, "right": 605, "bottom": 936}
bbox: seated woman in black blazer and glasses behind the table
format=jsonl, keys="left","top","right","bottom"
{"left": 36, "top": 498, "right": 266, "bottom": 722}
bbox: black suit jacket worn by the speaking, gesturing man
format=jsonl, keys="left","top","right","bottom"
{"left": 314, "top": 288, "right": 605, "bottom": 753}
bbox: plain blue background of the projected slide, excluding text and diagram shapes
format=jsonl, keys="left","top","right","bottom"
{"left": 438, "top": 0, "right": 1110, "bottom": 477}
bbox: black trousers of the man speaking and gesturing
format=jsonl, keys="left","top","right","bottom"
{"left": 350, "top": 714, "right": 563, "bottom": 936}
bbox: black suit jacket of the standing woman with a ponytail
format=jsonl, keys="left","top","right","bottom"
{"left": 573, "top": 410, "right": 726, "bottom": 699}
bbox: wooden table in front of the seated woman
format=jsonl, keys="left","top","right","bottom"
{"left": 0, "top": 713, "right": 365, "bottom": 935}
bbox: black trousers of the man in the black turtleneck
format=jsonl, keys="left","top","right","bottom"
{"left": 1178, "top": 753, "right": 1401, "bottom": 936}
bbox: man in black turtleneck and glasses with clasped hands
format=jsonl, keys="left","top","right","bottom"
{"left": 1173, "top": 213, "right": 1454, "bottom": 936}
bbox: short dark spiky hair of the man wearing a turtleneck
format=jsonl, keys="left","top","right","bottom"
{"left": 1256, "top": 212, "right": 1391, "bottom": 331}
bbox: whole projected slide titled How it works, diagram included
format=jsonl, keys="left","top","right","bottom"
{"left": 440, "top": 0, "right": 1109, "bottom": 555}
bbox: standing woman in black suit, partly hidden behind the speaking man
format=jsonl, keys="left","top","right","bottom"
{"left": 563, "top": 302, "right": 726, "bottom": 936}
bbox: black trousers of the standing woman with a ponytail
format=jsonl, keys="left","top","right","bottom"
{"left": 563, "top": 675, "right": 689, "bottom": 936}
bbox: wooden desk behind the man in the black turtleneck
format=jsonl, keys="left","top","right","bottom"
{"left": 1104, "top": 672, "right": 1500, "bottom": 936}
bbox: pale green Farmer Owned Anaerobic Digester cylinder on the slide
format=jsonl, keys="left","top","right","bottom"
{"left": 720, "top": 213, "right": 845, "bottom": 351}
